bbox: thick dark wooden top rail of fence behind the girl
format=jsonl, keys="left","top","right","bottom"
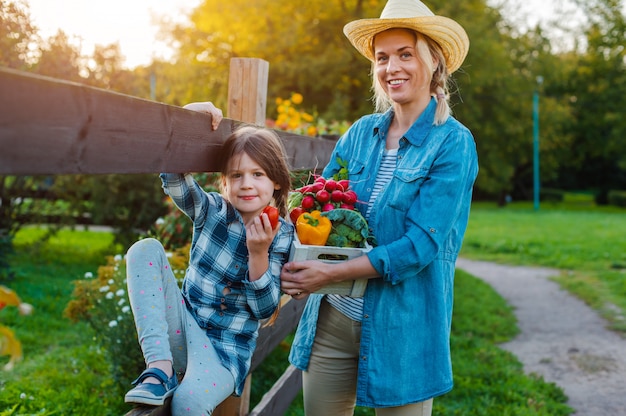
{"left": 0, "top": 68, "right": 334, "bottom": 175}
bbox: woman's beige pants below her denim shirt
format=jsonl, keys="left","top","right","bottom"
{"left": 302, "top": 301, "right": 433, "bottom": 416}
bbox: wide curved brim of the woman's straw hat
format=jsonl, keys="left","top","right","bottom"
{"left": 343, "top": 16, "right": 469, "bottom": 74}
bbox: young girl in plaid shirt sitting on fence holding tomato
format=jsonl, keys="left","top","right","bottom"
{"left": 125, "top": 118, "right": 294, "bottom": 415}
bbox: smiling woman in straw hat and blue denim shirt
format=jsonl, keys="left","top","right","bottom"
{"left": 281, "top": 0, "right": 478, "bottom": 416}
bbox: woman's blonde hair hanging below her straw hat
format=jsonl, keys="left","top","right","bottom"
{"left": 371, "top": 29, "right": 452, "bottom": 126}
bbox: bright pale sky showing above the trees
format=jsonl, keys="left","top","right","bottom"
{"left": 24, "top": 0, "right": 570, "bottom": 68}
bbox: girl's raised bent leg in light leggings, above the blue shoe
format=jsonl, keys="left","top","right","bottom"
{"left": 126, "top": 238, "right": 187, "bottom": 376}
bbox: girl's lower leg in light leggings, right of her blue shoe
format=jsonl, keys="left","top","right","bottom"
{"left": 172, "top": 311, "right": 235, "bottom": 416}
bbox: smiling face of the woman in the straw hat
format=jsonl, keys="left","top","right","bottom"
{"left": 374, "top": 29, "right": 430, "bottom": 105}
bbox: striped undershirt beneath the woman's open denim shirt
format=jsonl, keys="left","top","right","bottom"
{"left": 326, "top": 149, "right": 398, "bottom": 321}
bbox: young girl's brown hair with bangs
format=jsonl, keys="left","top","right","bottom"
{"left": 220, "top": 125, "right": 291, "bottom": 217}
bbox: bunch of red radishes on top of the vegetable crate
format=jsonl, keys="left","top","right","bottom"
{"left": 289, "top": 176, "right": 357, "bottom": 223}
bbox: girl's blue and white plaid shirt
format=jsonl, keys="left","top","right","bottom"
{"left": 161, "top": 174, "right": 294, "bottom": 395}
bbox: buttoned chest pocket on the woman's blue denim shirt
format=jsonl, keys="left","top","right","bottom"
{"left": 385, "top": 167, "right": 429, "bottom": 211}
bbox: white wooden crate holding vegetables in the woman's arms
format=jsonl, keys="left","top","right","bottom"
{"left": 289, "top": 235, "right": 372, "bottom": 298}
